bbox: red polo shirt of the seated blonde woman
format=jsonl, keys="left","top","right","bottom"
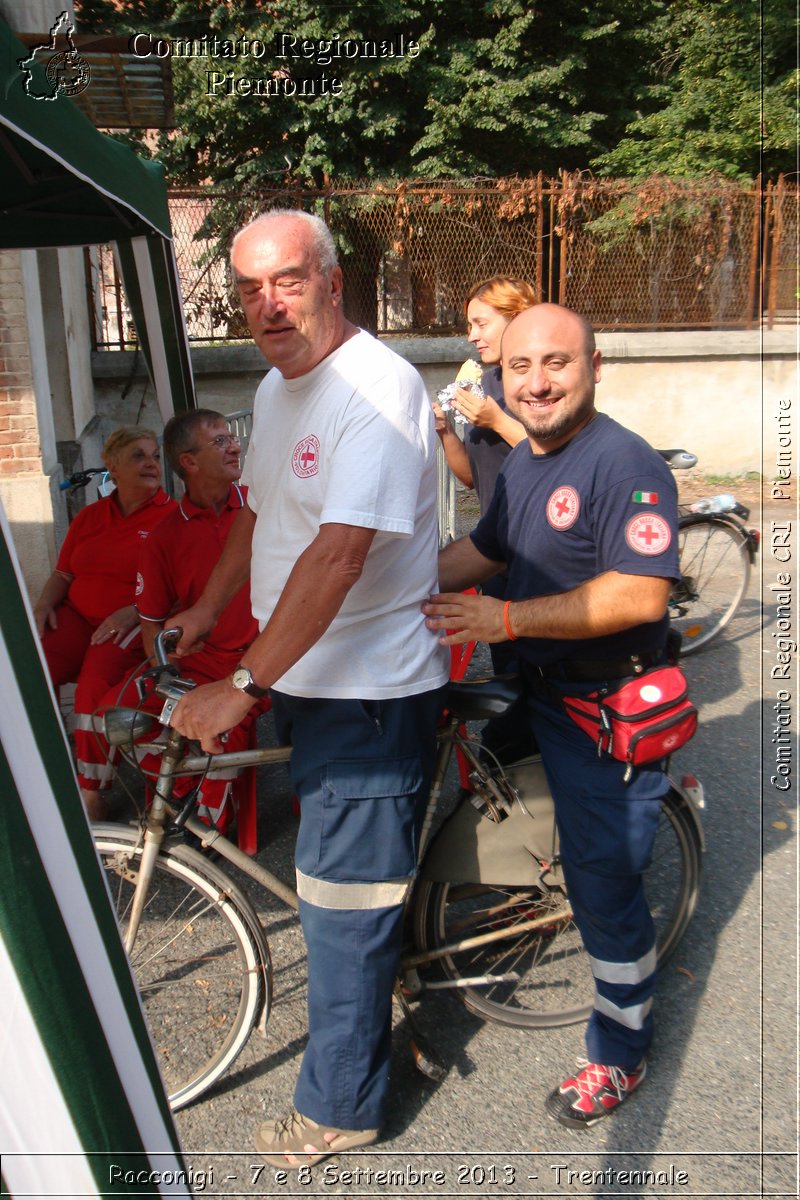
{"left": 55, "top": 488, "right": 176, "bottom": 625}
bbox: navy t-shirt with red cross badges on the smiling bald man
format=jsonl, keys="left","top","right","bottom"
{"left": 470, "top": 413, "right": 680, "bottom": 665}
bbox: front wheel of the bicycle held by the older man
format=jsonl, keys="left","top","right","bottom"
{"left": 92, "top": 824, "right": 272, "bottom": 1110}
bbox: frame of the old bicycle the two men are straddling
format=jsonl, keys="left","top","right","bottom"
{"left": 107, "top": 630, "right": 703, "bottom": 986}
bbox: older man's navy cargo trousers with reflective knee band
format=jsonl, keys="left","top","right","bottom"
{"left": 272, "top": 688, "right": 445, "bottom": 1129}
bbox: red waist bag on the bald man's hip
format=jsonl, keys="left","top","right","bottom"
{"left": 564, "top": 666, "right": 697, "bottom": 781}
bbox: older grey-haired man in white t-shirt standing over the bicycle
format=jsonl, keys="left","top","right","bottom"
{"left": 173, "top": 211, "right": 447, "bottom": 1165}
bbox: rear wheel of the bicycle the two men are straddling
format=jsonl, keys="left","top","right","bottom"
{"left": 413, "top": 788, "right": 700, "bottom": 1028}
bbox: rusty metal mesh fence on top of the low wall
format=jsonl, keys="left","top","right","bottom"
{"left": 91, "top": 174, "right": 799, "bottom": 348}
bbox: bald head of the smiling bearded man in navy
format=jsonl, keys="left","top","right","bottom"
{"left": 501, "top": 304, "right": 600, "bottom": 454}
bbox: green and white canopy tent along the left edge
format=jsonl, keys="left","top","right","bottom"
{"left": 0, "top": 19, "right": 193, "bottom": 1198}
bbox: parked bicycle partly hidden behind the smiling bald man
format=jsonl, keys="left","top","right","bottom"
{"left": 658, "top": 450, "right": 759, "bottom": 656}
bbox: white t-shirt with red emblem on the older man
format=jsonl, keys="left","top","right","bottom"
{"left": 237, "top": 330, "right": 449, "bottom": 700}
